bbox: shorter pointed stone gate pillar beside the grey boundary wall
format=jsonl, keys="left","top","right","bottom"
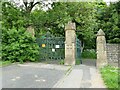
{"left": 96, "top": 29, "right": 107, "bottom": 68}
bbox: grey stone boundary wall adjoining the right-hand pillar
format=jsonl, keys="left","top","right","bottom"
{"left": 106, "top": 43, "right": 120, "bottom": 66}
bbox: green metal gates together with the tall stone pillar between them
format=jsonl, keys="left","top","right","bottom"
{"left": 37, "top": 22, "right": 81, "bottom": 65}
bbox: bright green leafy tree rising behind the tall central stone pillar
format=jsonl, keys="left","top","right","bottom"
{"left": 47, "top": 2, "right": 97, "bottom": 48}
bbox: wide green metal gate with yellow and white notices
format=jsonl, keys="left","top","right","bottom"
{"left": 37, "top": 32, "right": 65, "bottom": 60}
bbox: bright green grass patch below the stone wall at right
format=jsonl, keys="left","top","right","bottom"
{"left": 100, "top": 66, "right": 120, "bottom": 90}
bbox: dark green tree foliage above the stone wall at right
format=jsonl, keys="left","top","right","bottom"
{"left": 97, "top": 1, "right": 120, "bottom": 43}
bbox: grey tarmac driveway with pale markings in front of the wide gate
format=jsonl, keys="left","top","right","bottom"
{"left": 2, "top": 63, "right": 70, "bottom": 88}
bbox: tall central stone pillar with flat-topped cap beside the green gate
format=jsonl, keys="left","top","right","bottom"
{"left": 64, "top": 22, "right": 76, "bottom": 65}
